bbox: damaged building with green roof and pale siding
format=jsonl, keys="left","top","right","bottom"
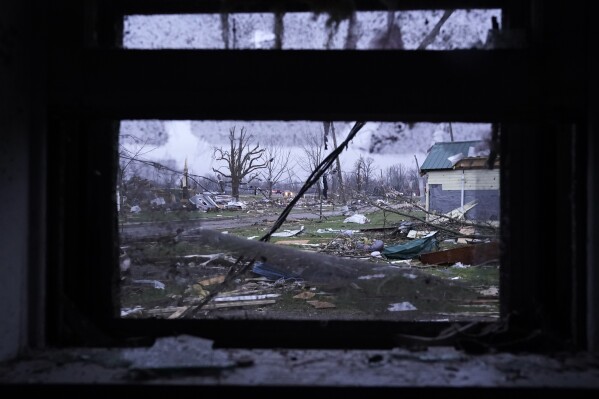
{"left": 420, "top": 141, "right": 500, "bottom": 221}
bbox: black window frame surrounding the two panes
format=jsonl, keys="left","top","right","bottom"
{"left": 47, "top": 0, "right": 587, "bottom": 350}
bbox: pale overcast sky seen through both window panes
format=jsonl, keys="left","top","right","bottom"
{"left": 121, "top": 10, "right": 501, "bottom": 184}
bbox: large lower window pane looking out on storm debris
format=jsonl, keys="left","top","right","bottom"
{"left": 116, "top": 120, "right": 500, "bottom": 321}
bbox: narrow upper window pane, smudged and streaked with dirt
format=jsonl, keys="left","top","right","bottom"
{"left": 123, "top": 9, "right": 506, "bottom": 50}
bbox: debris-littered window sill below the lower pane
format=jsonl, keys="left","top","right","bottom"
{"left": 0, "top": 336, "right": 599, "bottom": 396}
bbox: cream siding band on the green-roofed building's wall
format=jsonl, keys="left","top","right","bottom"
{"left": 427, "top": 169, "right": 499, "bottom": 190}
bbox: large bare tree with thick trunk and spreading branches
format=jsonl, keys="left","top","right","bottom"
{"left": 212, "top": 126, "right": 266, "bottom": 201}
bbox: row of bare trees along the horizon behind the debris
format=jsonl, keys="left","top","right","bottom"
{"left": 117, "top": 122, "right": 420, "bottom": 209}
